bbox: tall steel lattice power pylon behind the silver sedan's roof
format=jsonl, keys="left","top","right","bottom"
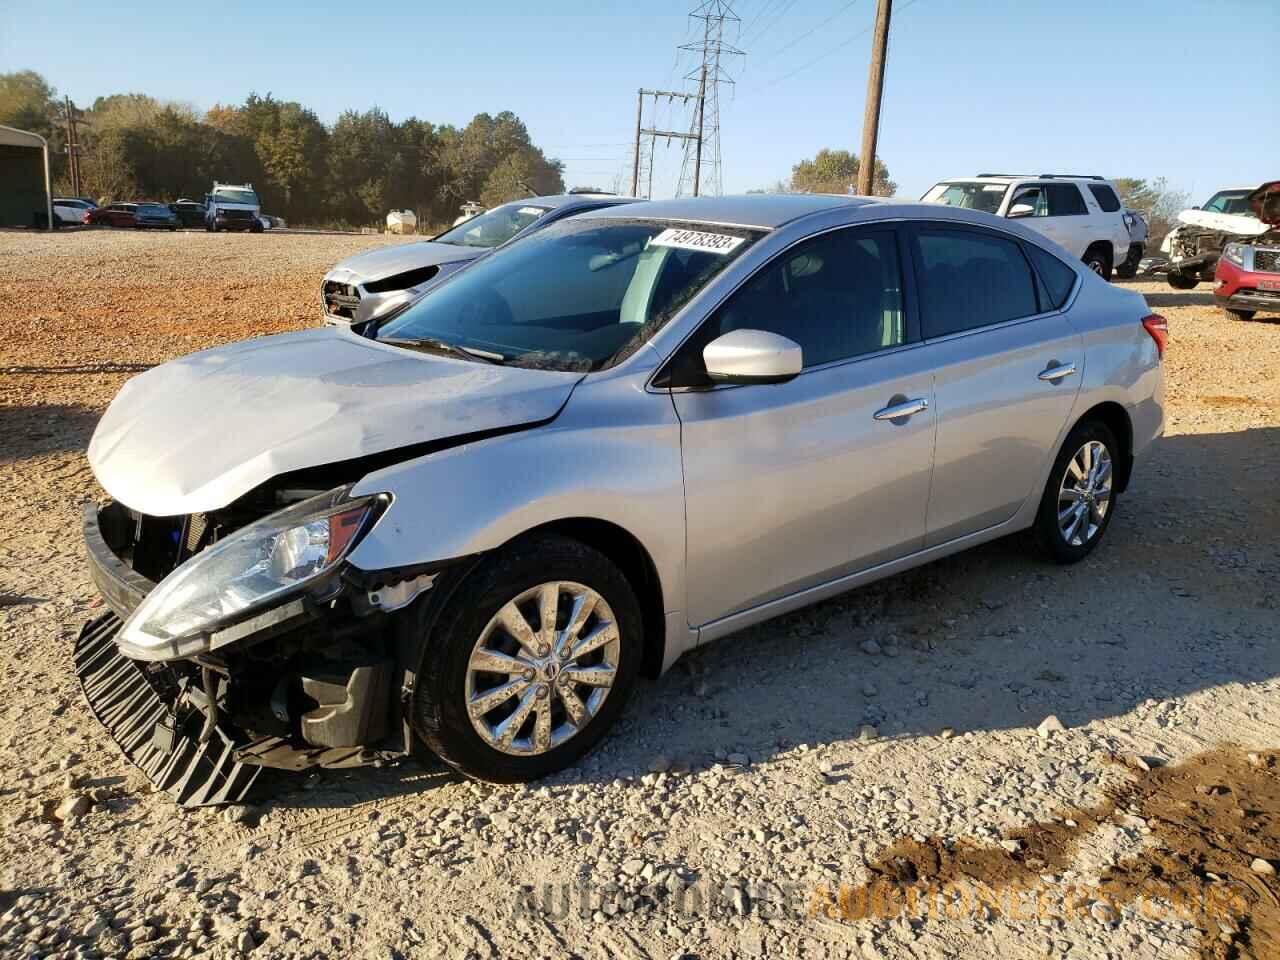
{"left": 676, "top": 0, "right": 745, "bottom": 197}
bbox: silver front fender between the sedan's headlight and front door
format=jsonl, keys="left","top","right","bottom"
{"left": 351, "top": 375, "right": 685, "bottom": 634}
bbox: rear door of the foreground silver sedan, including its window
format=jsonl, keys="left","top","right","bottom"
{"left": 911, "top": 224, "right": 1084, "bottom": 547}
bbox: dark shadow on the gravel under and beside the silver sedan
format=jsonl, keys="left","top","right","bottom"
{"left": 235, "top": 428, "right": 1280, "bottom": 832}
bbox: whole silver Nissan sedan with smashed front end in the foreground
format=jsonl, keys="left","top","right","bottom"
{"left": 76, "top": 195, "right": 1166, "bottom": 805}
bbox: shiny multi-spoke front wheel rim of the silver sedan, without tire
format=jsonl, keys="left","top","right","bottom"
{"left": 463, "top": 581, "right": 622, "bottom": 756}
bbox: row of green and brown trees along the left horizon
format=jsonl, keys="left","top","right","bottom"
{"left": 0, "top": 70, "right": 564, "bottom": 225}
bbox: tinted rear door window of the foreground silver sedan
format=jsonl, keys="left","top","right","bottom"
{"left": 916, "top": 228, "right": 1039, "bottom": 339}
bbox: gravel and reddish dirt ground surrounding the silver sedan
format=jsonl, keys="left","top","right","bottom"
{"left": 0, "top": 230, "right": 1280, "bottom": 960}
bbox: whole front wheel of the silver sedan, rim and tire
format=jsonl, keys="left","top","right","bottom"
{"left": 410, "top": 536, "right": 643, "bottom": 783}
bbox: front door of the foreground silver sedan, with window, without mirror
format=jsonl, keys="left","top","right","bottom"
{"left": 669, "top": 227, "right": 933, "bottom": 626}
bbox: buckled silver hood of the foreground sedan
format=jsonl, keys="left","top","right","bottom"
{"left": 88, "top": 328, "right": 582, "bottom": 516}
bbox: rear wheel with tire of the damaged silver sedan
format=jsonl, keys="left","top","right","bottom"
{"left": 1034, "top": 420, "right": 1119, "bottom": 563}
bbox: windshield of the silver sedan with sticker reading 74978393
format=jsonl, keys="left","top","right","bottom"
{"left": 374, "top": 219, "right": 760, "bottom": 371}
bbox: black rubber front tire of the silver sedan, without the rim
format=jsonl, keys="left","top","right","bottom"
{"left": 408, "top": 536, "right": 644, "bottom": 783}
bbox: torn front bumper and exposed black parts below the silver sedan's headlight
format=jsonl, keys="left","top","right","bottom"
{"left": 74, "top": 503, "right": 407, "bottom": 806}
